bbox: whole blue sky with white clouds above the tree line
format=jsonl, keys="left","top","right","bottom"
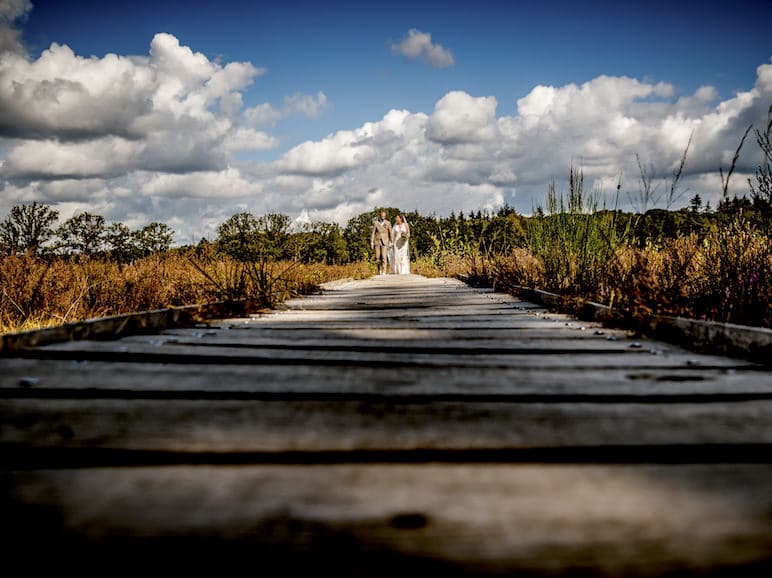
{"left": 0, "top": 0, "right": 772, "bottom": 238}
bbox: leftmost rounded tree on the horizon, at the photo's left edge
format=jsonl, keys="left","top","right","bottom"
{"left": 0, "top": 202, "right": 59, "bottom": 254}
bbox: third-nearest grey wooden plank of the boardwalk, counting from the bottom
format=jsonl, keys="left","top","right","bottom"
{"left": 0, "top": 359, "right": 772, "bottom": 399}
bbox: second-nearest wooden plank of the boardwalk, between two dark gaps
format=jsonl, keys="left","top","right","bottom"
{"left": 0, "top": 396, "right": 772, "bottom": 452}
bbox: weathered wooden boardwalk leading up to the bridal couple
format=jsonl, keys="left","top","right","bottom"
{"left": 0, "top": 276, "right": 772, "bottom": 576}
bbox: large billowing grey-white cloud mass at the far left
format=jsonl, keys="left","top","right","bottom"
{"left": 0, "top": 25, "right": 277, "bottom": 179}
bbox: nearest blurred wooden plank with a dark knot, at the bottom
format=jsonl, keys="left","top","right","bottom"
{"left": 0, "top": 464, "right": 772, "bottom": 577}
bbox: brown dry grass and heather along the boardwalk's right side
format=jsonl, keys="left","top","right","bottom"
{"left": 447, "top": 218, "right": 772, "bottom": 327}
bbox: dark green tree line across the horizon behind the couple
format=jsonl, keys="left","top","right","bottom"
{"left": 0, "top": 189, "right": 772, "bottom": 265}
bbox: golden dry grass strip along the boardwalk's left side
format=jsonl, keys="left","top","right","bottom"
{"left": 0, "top": 253, "right": 373, "bottom": 333}
